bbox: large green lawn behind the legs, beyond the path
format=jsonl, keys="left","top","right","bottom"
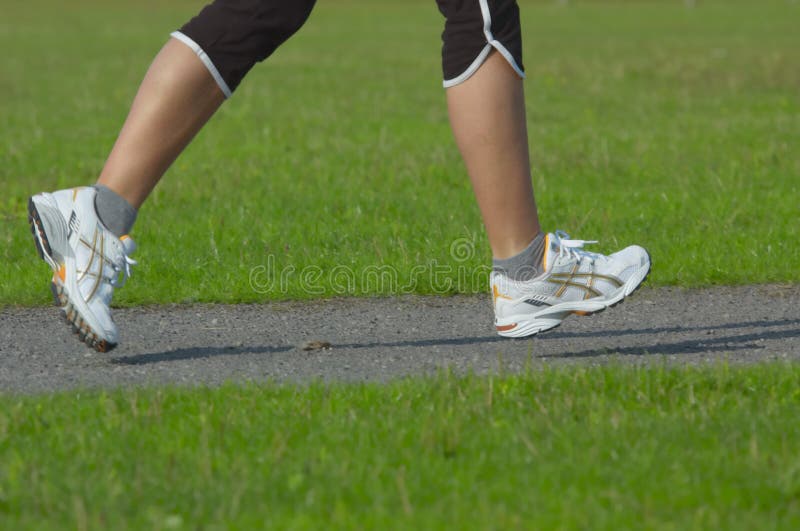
{"left": 0, "top": 0, "right": 800, "bottom": 304}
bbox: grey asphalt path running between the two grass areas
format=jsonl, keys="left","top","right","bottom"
{"left": 0, "top": 285, "right": 800, "bottom": 394}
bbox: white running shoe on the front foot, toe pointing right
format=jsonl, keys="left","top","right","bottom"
{"left": 490, "top": 231, "right": 650, "bottom": 337}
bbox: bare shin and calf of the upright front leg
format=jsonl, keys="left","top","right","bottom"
{"left": 447, "top": 52, "right": 540, "bottom": 258}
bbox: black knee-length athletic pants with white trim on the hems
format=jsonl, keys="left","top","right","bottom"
{"left": 172, "top": 0, "right": 525, "bottom": 97}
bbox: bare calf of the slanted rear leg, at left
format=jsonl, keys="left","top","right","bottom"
{"left": 97, "top": 39, "right": 225, "bottom": 208}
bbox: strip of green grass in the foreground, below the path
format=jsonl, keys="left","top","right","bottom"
{"left": 0, "top": 364, "right": 800, "bottom": 529}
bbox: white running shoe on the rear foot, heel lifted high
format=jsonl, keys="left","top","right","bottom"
{"left": 28, "top": 187, "right": 136, "bottom": 352}
